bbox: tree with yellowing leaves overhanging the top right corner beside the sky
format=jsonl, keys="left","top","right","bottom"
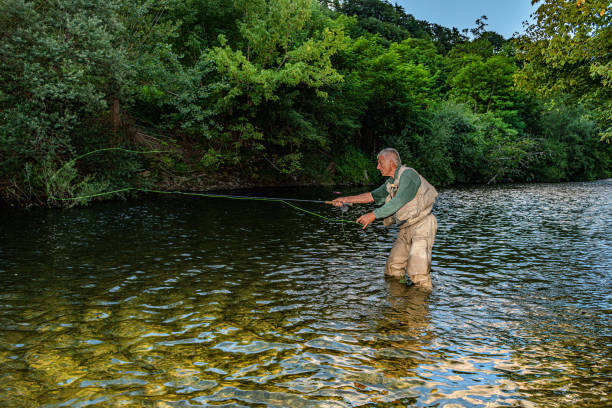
{"left": 517, "top": 0, "right": 612, "bottom": 140}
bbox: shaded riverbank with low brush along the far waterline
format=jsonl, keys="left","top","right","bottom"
{"left": 0, "top": 128, "right": 612, "bottom": 208}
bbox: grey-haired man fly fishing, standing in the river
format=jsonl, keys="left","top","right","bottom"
{"left": 333, "top": 148, "right": 438, "bottom": 292}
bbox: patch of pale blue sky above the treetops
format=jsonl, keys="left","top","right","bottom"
{"left": 389, "top": 0, "right": 537, "bottom": 38}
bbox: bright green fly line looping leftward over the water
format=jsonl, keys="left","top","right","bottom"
{"left": 47, "top": 147, "right": 354, "bottom": 225}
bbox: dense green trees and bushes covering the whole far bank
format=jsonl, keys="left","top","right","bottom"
{"left": 0, "top": 0, "right": 612, "bottom": 205}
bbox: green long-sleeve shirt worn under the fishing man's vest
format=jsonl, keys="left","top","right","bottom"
{"left": 371, "top": 167, "right": 421, "bottom": 219}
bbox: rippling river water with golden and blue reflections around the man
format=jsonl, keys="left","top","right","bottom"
{"left": 0, "top": 181, "right": 612, "bottom": 407}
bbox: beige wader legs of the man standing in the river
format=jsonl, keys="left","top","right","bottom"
{"left": 385, "top": 213, "right": 438, "bottom": 291}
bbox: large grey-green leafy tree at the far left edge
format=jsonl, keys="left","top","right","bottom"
{"left": 0, "top": 0, "right": 133, "bottom": 201}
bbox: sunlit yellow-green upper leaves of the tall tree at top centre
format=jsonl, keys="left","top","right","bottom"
{"left": 210, "top": 0, "right": 343, "bottom": 105}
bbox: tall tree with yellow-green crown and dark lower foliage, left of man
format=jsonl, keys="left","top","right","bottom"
{"left": 208, "top": 0, "right": 344, "bottom": 172}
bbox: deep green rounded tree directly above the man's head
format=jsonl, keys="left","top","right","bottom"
{"left": 342, "top": 36, "right": 441, "bottom": 152}
